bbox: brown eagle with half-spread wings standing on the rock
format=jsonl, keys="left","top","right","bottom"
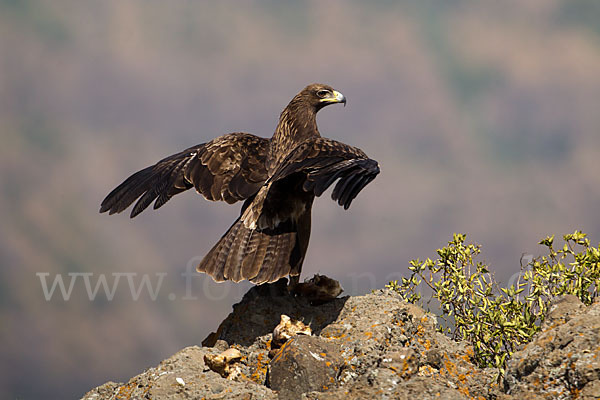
{"left": 100, "top": 84, "right": 379, "bottom": 285}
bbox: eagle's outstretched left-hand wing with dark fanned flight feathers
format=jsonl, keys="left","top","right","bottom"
{"left": 100, "top": 133, "right": 269, "bottom": 218}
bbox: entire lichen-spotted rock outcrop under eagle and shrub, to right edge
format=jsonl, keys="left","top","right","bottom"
{"left": 83, "top": 281, "right": 600, "bottom": 400}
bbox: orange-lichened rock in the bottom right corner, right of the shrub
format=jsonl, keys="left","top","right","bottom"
{"left": 505, "top": 296, "right": 600, "bottom": 399}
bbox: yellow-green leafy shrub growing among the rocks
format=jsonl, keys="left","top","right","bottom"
{"left": 386, "top": 231, "right": 600, "bottom": 378}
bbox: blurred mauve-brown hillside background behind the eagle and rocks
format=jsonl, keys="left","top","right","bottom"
{"left": 0, "top": 0, "right": 600, "bottom": 399}
